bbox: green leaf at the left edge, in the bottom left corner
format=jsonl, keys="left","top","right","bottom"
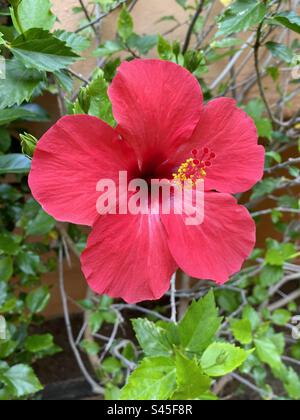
{"left": 0, "top": 364, "right": 43, "bottom": 398}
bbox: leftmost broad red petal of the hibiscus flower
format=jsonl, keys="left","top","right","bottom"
{"left": 29, "top": 115, "right": 137, "bottom": 225}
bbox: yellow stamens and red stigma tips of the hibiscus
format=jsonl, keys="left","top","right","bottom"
{"left": 173, "top": 147, "right": 216, "bottom": 186}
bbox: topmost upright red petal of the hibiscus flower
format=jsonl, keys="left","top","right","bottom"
{"left": 109, "top": 60, "right": 203, "bottom": 167}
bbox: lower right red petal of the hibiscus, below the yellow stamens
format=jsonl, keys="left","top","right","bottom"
{"left": 161, "top": 192, "right": 256, "bottom": 284}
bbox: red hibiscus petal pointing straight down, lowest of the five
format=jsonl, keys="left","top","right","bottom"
{"left": 81, "top": 215, "right": 177, "bottom": 303}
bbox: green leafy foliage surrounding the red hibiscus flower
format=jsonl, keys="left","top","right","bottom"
{"left": 0, "top": 0, "right": 300, "bottom": 400}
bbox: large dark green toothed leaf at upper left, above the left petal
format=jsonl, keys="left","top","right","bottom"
{"left": 10, "top": 29, "right": 79, "bottom": 72}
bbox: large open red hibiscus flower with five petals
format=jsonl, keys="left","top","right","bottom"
{"left": 29, "top": 60, "right": 264, "bottom": 303}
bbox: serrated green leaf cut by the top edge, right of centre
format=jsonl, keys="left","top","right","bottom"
{"left": 216, "top": 0, "right": 267, "bottom": 36}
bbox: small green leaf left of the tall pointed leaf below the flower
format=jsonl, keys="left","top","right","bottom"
{"left": 132, "top": 318, "right": 173, "bottom": 356}
